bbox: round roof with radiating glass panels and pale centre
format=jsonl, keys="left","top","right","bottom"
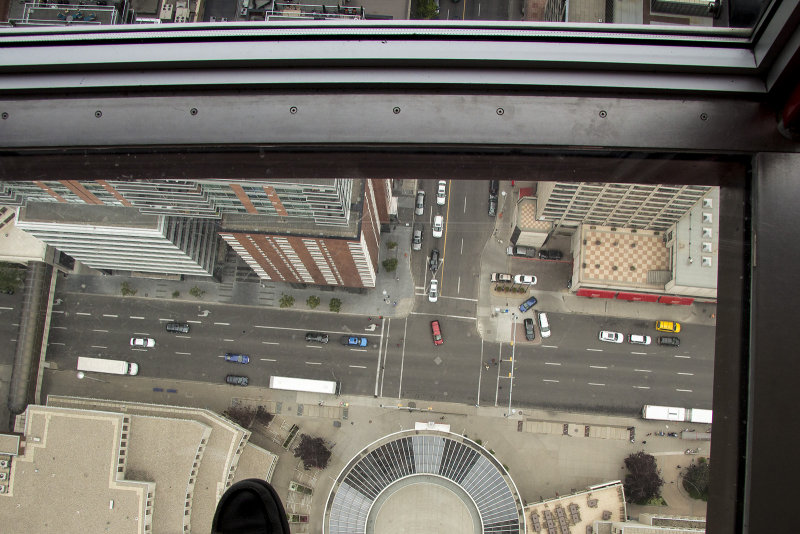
{"left": 323, "top": 430, "right": 525, "bottom": 534}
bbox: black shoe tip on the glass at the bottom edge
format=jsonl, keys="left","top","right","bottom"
{"left": 211, "top": 478, "right": 289, "bottom": 534}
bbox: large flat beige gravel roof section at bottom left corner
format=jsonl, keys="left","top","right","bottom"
{"left": 0, "top": 405, "right": 152, "bottom": 534}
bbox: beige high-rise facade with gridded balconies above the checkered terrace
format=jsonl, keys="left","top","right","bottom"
{"left": 536, "top": 182, "right": 711, "bottom": 234}
